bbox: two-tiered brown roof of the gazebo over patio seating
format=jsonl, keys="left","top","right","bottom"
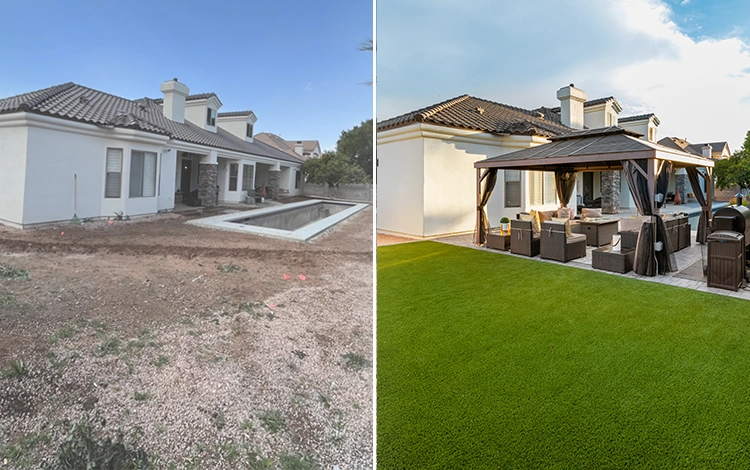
{"left": 474, "top": 126, "right": 714, "bottom": 171}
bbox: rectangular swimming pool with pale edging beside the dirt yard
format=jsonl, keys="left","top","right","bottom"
{"left": 188, "top": 199, "right": 367, "bottom": 241}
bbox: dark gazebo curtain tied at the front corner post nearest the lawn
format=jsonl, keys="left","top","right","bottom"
{"left": 622, "top": 159, "right": 676, "bottom": 276}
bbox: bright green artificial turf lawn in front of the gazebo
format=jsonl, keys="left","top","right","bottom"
{"left": 377, "top": 242, "right": 750, "bottom": 469}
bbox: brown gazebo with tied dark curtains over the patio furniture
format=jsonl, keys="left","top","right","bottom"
{"left": 474, "top": 126, "right": 714, "bottom": 276}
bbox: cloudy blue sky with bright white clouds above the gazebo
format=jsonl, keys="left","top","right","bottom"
{"left": 376, "top": 0, "right": 750, "bottom": 151}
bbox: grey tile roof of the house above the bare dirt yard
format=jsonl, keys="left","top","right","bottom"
{"left": 0, "top": 82, "right": 302, "bottom": 163}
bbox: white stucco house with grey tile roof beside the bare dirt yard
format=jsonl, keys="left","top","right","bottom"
{"left": 0, "top": 79, "right": 302, "bottom": 228}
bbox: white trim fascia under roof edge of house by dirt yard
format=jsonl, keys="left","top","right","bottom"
{"left": 0, "top": 111, "right": 169, "bottom": 145}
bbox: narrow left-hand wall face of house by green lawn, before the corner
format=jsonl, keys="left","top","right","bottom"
{"left": 375, "top": 130, "right": 424, "bottom": 237}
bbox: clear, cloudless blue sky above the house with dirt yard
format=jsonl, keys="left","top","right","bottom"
{"left": 0, "top": 0, "right": 373, "bottom": 150}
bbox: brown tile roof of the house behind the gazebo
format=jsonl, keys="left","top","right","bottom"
{"left": 378, "top": 95, "right": 570, "bottom": 137}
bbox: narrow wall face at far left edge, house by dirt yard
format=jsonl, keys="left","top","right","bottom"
{"left": 0, "top": 122, "right": 28, "bottom": 226}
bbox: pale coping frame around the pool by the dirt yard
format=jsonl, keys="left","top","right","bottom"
{"left": 187, "top": 199, "right": 368, "bottom": 242}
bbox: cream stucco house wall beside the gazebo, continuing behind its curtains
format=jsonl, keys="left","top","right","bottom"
{"left": 376, "top": 124, "right": 557, "bottom": 237}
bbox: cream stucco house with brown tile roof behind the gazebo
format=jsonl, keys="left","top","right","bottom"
{"left": 376, "top": 84, "right": 692, "bottom": 238}
